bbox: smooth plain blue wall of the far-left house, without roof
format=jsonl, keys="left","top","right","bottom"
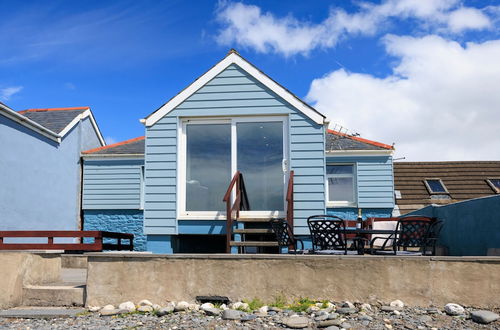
{"left": 0, "top": 115, "right": 100, "bottom": 230}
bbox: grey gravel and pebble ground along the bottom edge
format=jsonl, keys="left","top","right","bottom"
{"left": 0, "top": 307, "right": 500, "bottom": 330}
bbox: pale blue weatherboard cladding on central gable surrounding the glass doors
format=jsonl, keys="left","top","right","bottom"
{"left": 144, "top": 64, "right": 325, "bottom": 235}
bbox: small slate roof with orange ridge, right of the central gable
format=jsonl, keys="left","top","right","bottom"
{"left": 325, "top": 129, "right": 394, "bottom": 152}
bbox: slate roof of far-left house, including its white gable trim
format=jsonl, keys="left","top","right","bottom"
{"left": 18, "top": 107, "right": 106, "bottom": 146}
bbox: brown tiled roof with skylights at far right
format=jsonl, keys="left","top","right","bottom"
{"left": 394, "top": 161, "right": 500, "bottom": 214}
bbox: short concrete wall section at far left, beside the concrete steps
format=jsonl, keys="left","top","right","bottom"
{"left": 0, "top": 252, "right": 61, "bottom": 308}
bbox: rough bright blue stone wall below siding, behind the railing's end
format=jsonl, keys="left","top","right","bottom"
{"left": 84, "top": 210, "right": 147, "bottom": 251}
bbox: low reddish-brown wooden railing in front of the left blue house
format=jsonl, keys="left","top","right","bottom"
{"left": 0, "top": 230, "right": 134, "bottom": 252}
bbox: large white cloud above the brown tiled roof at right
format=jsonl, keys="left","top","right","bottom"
{"left": 307, "top": 35, "right": 500, "bottom": 160}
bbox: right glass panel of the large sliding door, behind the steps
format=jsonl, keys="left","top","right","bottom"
{"left": 236, "top": 121, "right": 284, "bottom": 211}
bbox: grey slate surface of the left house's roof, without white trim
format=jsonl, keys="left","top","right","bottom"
{"left": 19, "top": 108, "right": 88, "bottom": 134}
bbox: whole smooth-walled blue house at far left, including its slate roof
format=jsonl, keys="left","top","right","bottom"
{"left": 0, "top": 103, "right": 105, "bottom": 230}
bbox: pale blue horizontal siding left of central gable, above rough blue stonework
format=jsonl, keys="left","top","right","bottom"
{"left": 82, "top": 159, "right": 144, "bottom": 210}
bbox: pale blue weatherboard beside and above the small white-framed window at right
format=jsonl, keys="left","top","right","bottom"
{"left": 326, "top": 156, "right": 394, "bottom": 209}
